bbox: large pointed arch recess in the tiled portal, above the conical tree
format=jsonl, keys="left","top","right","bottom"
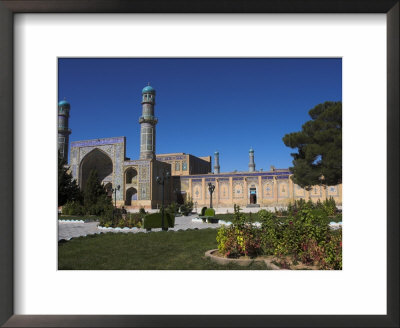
{"left": 79, "top": 148, "right": 113, "bottom": 190}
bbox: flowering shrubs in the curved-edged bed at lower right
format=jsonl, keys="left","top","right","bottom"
{"left": 217, "top": 203, "right": 342, "bottom": 270}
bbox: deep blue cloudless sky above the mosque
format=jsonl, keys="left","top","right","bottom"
{"left": 58, "top": 58, "right": 342, "bottom": 172}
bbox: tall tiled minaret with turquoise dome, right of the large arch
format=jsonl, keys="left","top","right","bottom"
{"left": 139, "top": 85, "right": 158, "bottom": 159}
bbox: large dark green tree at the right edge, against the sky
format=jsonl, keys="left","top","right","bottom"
{"left": 282, "top": 101, "right": 342, "bottom": 190}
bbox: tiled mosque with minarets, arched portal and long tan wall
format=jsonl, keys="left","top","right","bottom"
{"left": 58, "top": 85, "right": 342, "bottom": 209}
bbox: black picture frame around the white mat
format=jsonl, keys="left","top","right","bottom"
{"left": 0, "top": 0, "right": 400, "bottom": 327}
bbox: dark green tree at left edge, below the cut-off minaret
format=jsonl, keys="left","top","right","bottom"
{"left": 58, "top": 153, "right": 82, "bottom": 206}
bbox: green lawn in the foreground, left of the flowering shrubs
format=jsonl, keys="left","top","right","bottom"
{"left": 58, "top": 229, "right": 267, "bottom": 270}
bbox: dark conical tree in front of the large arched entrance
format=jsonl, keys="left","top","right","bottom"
{"left": 83, "top": 170, "right": 112, "bottom": 215}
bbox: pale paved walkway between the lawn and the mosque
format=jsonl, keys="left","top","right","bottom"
{"left": 58, "top": 215, "right": 220, "bottom": 240}
